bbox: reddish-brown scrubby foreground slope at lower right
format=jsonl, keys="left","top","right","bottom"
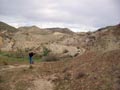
{"left": 56, "top": 50, "right": 120, "bottom": 90}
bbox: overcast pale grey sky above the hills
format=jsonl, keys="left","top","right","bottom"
{"left": 0, "top": 0, "right": 120, "bottom": 32}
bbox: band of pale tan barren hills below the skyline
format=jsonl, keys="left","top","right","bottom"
{"left": 0, "top": 23, "right": 120, "bottom": 56}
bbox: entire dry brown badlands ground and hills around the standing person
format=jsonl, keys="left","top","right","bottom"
{"left": 0, "top": 22, "right": 120, "bottom": 90}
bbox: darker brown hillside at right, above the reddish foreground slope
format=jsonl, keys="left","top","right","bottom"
{"left": 81, "top": 25, "right": 120, "bottom": 51}
